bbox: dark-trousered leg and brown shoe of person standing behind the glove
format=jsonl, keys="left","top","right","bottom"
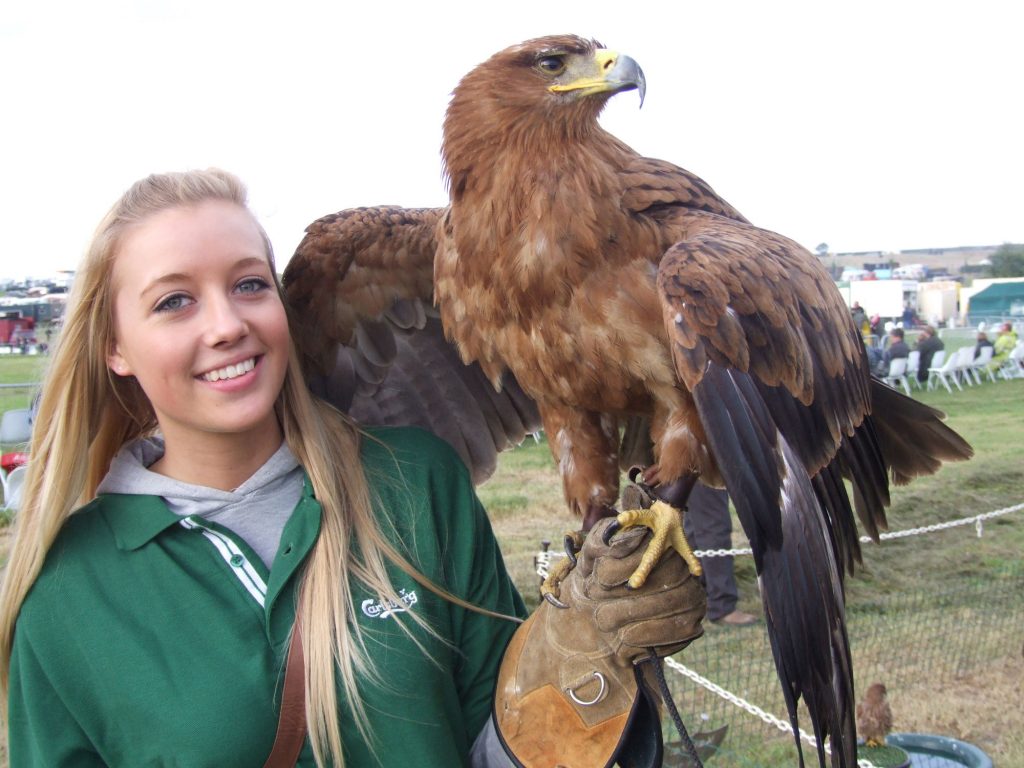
{"left": 683, "top": 482, "right": 758, "bottom": 627}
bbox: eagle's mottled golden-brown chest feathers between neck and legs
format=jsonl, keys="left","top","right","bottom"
{"left": 436, "top": 173, "right": 673, "bottom": 411}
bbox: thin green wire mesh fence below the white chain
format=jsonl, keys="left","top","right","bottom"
{"left": 666, "top": 563, "right": 1024, "bottom": 768}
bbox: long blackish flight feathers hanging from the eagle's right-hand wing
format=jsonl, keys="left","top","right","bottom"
{"left": 692, "top": 364, "right": 856, "bottom": 765}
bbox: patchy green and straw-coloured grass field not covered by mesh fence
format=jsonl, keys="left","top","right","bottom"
{"left": 0, "top": 355, "right": 1024, "bottom": 767}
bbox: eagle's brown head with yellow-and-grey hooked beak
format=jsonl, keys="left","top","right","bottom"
{"left": 441, "top": 35, "right": 646, "bottom": 186}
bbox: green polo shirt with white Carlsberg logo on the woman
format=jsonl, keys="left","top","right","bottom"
{"left": 8, "top": 429, "right": 524, "bottom": 768}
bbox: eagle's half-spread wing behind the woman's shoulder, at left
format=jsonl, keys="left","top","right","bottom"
{"left": 284, "top": 206, "right": 540, "bottom": 482}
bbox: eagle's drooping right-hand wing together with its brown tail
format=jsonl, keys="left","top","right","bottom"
{"left": 657, "top": 209, "right": 971, "bottom": 764}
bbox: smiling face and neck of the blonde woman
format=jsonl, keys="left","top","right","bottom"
{"left": 108, "top": 201, "right": 289, "bottom": 460}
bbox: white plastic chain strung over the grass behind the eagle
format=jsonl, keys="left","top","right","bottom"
{"left": 534, "top": 504, "right": 1024, "bottom": 768}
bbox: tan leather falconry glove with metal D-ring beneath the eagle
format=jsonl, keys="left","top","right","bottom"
{"left": 495, "top": 518, "right": 707, "bottom": 768}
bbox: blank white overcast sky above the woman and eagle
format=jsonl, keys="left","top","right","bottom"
{"left": 0, "top": 0, "right": 1024, "bottom": 278}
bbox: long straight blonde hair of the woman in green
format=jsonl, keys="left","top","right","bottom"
{"left": 0, "top": 169, "right": 434, "bottom": 768}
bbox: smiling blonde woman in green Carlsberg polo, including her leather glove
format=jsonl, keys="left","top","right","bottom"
{"left": 0, "top": 170, "right": 702, "bottom": 768}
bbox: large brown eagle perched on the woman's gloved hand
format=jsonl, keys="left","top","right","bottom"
{"left": 284, "top": 35, "right": 972, "bottom": 766}
